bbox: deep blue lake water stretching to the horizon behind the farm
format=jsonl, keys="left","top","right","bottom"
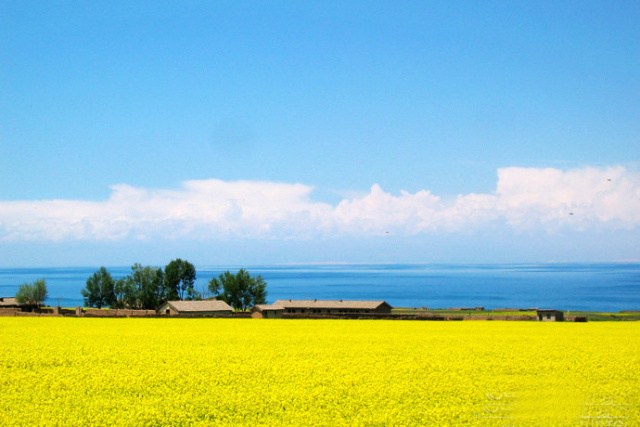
{"left": 0, "top": 263, "right": 640, "bottom": 312}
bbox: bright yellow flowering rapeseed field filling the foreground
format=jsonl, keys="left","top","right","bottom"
{"left": 0, "top": 318, "right": 640, "bottom": 426}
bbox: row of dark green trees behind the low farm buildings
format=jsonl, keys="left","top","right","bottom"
{"left": 82, "top": 258, "right": 267, "bottom": 310}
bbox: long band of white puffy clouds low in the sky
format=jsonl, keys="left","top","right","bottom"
{"left": 0, "top": 166, "right": 640, "bottom": 242}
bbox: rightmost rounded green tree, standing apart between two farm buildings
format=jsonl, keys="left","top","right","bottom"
{"left": 209, "top": 268, "right": 267, "bottom": 311}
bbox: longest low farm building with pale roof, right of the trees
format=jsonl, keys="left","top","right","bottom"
{"left": 251, "top": 299, "right": 391, "bottom": 319}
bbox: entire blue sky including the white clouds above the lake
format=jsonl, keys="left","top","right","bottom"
{"left": 0, "top": 1, "right": 640, "bottom": 266}
